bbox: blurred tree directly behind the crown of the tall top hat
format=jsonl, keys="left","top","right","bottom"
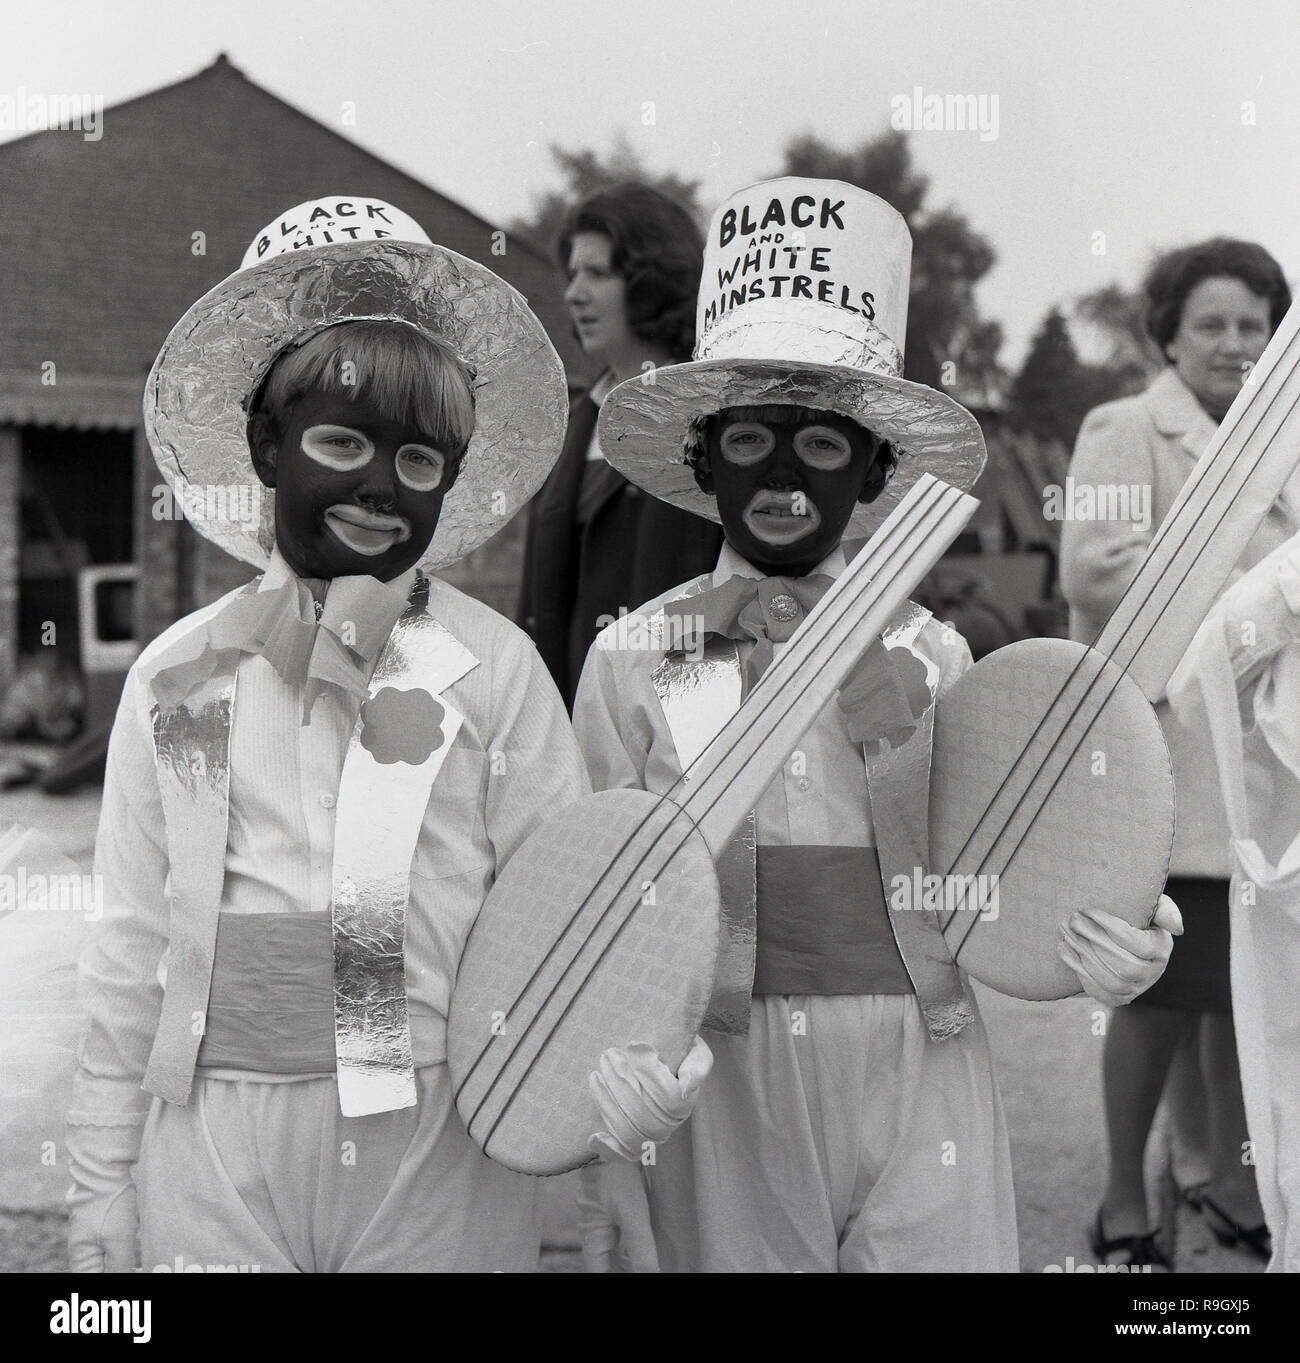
{"left": 779, "top": 131, "right": 1006, "bottom": 406}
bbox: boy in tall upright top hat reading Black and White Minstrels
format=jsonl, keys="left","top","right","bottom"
{"left": 574, "top": 179, "right": 1176, "bottom": 1272}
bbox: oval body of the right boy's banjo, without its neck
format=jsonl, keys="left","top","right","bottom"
{"left": 929, "top": 639, "right": 1173, "bottom": 999}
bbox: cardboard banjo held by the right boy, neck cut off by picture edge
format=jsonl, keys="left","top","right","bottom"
{"left": 931, "top": 304, "right": 1300, "bottom": 999}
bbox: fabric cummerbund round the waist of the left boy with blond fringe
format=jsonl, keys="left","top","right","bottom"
{"left": 198, "top": 913, "right": 447, "bottom": 1074}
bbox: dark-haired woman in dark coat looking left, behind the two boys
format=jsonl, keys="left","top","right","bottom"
{"left": 518, "top": 184, "right": 722, "bottom": 709}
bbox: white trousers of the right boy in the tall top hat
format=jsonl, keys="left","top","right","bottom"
{"left": 646, "top": 995, "right": 1019, "bottom": 1273}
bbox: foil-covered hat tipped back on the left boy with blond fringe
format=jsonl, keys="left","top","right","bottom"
{"left": 144, "top": 195, "right": 568, "bottom": 568}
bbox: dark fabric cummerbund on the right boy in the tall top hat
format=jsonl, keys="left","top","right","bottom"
{"left": 754, "top": 844, "right": 913, "bottom": 994}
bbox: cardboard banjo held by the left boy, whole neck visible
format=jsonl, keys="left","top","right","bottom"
{"left": 447, "top": 476, "right": 976, "bottom": 1174}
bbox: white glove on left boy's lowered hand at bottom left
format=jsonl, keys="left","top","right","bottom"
{"left": 67, "top": 1126, "right": 140, "bottom": 1273}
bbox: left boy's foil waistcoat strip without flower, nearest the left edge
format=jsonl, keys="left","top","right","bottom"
{"left": 144, "top": 673, "right": 234, "bottom": 1103}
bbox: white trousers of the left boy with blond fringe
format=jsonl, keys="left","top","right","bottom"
{"left": 136, "top": 1065, "right": 541, "bottom": 1273}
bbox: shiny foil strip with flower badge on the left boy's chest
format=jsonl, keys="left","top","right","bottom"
{"left": 331, "top": 581, "right": 478, "bottom": 1116}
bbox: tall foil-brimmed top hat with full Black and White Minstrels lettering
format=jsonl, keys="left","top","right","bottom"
{"left": 598, "top": 177, "right": 985, "bottom": 540}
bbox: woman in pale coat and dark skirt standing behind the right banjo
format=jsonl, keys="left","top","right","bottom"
{"left": 1060, "top": 237, "right": 1300, "bottom": 1264}
